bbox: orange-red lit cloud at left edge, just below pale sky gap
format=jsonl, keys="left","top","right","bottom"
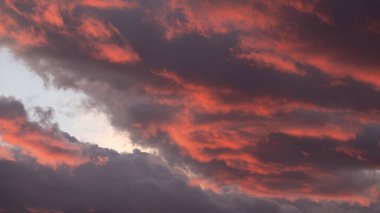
{"left": 0, "top": 97, "right": 86, "bottom": 167}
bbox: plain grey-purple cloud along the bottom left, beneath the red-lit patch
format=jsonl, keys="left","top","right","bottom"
{"left": 0, "top": 148, "right": 299, "bottom": 213}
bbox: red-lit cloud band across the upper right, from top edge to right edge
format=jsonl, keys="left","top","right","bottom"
{"left": 158, "top": 0, "right": 380, "bottom": 87}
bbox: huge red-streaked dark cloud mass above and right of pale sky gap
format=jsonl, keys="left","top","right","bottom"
{"left": 0, "top": 0, "right": 380, "bottom": 211}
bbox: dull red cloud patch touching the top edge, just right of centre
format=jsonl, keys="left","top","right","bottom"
{"left": 157, "top": 0, "right": 276, "bottom": 39}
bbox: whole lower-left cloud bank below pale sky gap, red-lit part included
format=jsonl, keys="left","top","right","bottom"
{"left": 0, "top": 97, "right": 306, "bottom": 213}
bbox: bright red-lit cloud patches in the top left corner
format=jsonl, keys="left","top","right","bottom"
{"left": 0, "top": 0, "right": 140, "bottom": 63}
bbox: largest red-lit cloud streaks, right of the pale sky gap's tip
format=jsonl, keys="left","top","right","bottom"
{"left": 135, "top": 70, "right": 376, "bottom": 205}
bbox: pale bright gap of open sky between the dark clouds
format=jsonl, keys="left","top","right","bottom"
{"left": 0, "top": 48, "right": 136, "bottom": 152}
